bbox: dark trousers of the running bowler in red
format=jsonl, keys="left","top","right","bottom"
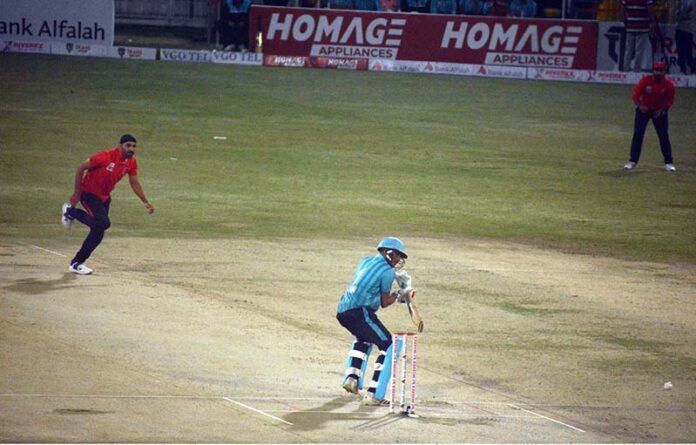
{"left": 69, "top": 193, "right": 111, "bottom": 264}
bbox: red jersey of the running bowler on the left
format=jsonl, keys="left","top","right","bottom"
{"left": 82, "top": 147, "right": 138, "bottom": 201}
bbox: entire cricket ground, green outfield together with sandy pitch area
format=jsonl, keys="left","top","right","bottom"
{"left": 0, "top": 53, "right": 696, "bottom": 443}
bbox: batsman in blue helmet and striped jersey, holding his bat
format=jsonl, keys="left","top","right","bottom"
{"left": 336, "top": 237, "right": 423, "bottom": 405}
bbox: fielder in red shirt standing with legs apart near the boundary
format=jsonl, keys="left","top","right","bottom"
{"left": 624, "top": 62, "right": 676, "bottom": 172}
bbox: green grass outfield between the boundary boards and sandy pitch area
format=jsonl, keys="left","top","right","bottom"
{"left": 0, "top": 53, "right": 696, "bottom": 263}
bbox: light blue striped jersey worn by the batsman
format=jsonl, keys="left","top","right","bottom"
{"left": 338, "top": 254, "right": 394, "bottom": 313}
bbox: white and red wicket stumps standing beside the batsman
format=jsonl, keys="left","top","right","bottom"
{"left": 389, "top": 332, "right": 418, "bottom": 417}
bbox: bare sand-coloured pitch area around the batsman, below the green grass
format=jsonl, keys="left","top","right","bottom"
{"left": 0, "top": 234, "right": 696, "bottom": 443}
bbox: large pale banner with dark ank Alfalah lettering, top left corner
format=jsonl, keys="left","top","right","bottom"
{"left": 0, "top": 0, "right": 114, "bottom": 46}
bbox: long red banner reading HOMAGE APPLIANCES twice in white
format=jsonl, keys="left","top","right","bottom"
{"left": 249, "top": 5, "right": 597, "bottom": 70}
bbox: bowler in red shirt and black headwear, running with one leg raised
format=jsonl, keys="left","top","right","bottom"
{"left": 63, "top": 134, "right": 155, "bottom": 275}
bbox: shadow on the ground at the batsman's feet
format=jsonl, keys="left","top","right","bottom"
{"left": 283, "top": 396, "right": 401, "bottom": 431}
